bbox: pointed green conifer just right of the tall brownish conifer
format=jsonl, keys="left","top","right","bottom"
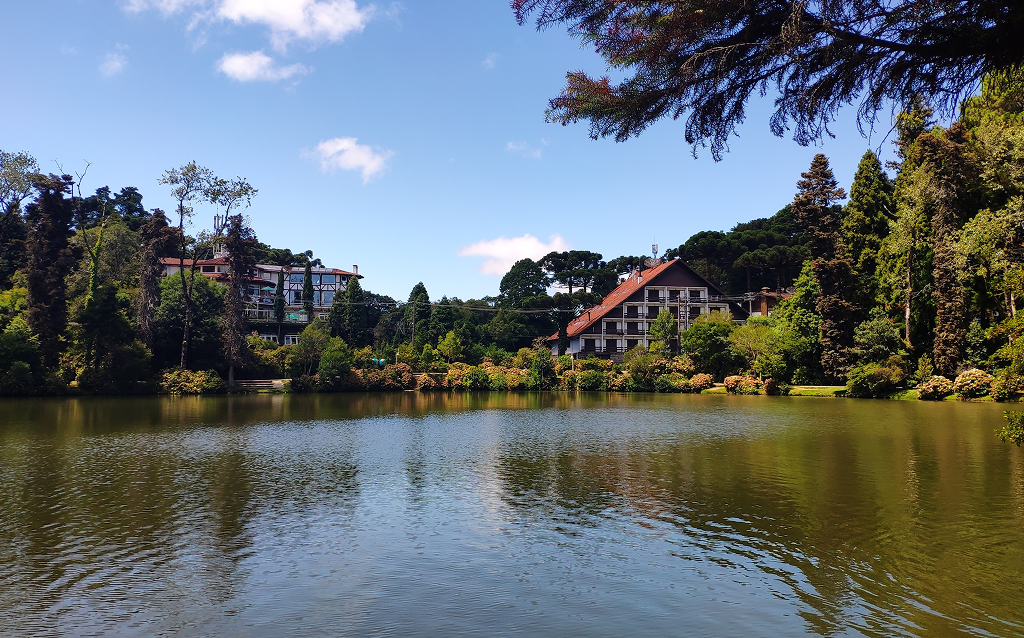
{"left": 843, "top": 151, "right": 894, "bottom": 311}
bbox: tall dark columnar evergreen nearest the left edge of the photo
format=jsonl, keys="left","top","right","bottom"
{"left": 25, "top": 175, "right": 77, "bottom": 368}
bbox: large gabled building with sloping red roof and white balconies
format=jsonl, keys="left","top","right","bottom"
{"left": 548, "top": 259, "right": 749, "bottom": 360}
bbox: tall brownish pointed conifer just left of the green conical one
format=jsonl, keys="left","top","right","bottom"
{"left": 793, "top": 153, "right": 856, "bottom": 379}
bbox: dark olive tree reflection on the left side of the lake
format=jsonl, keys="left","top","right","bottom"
{"left": 0, "top": 399, "right": 359, "bottom": 634}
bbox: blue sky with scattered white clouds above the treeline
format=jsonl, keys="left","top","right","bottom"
{"left": 6, "top": 0, "right": 905, "bottom": 299}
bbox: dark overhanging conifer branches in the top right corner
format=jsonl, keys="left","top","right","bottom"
{"left": 512, "top": 0, "right": 1024, "bottom": 159}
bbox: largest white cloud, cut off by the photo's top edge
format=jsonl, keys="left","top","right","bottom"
{"left": 124, "top": 0, "right": 374, "bottom": 51}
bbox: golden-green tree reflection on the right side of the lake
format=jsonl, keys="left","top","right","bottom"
{"left": 498, "top": 405, "right": 1024, "bottom": 636}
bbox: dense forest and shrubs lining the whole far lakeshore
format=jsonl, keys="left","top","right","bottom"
{"left": 6, "top": 72, "right": 1024, "bottom": 430}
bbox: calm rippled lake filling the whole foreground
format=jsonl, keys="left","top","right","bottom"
{"left": 0, "top": 392, "right": 1024, "bottom": 636}
